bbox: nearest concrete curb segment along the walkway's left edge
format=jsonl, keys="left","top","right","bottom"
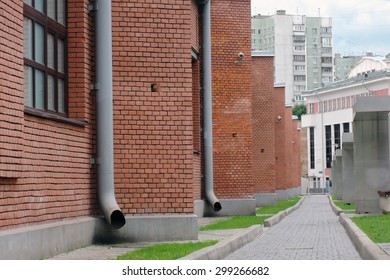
{"left": 180, "top": 225, "right": 264, "bottom": 260}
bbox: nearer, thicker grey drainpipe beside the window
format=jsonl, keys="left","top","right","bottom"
{"left": 95, "top": 0, "right": 126, "bottom": 229}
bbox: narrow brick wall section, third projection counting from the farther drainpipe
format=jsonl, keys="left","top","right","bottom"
{"left": 275, "top": 87, "right": 286, "bottom": 190}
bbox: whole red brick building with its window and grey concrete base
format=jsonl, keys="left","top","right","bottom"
{"left": 0, "top": 0, "right": 302, "bottom": 259}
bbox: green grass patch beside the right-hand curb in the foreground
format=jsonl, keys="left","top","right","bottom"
{"left": 352, "top": 215, "right": 390, "bottom": 243}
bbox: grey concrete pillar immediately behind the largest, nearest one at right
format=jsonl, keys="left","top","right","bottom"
{"left": 342, "top": 133, "right": 356, "bottom": 203}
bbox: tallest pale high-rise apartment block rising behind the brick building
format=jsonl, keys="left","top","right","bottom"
{"left": 252, "top": 10, "right": 333, "bottom": 105}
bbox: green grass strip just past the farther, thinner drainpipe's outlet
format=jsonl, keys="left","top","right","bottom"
{"left": 200, "top": 216, "right": 271, "bottom": 230}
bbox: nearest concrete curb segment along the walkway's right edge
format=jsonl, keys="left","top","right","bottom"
{"left": 339, "top": 213, "right": 390, "bottom": 260}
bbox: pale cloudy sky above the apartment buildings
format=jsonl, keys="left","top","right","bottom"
{"left": 251, "top": 0, "right": 390, "bottom": 56}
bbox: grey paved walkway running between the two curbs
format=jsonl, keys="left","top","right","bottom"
{"left": 225, "top": 195, "right": 361, "bottom": 260}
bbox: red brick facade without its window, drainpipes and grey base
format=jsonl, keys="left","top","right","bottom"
{"left": 0, "top": 0, "right": 302, "bottom": 236}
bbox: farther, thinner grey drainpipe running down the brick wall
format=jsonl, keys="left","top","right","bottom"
{"left": 198, "top": 0, "right": 222, "bottom": 212}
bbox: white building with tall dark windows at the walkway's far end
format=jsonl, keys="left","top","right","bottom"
{"left": 302, "top": 69, "right": 390, "bottom": 190}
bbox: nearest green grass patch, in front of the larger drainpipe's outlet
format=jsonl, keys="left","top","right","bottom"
{"left": 117, "top": 240, "right": 218, "bottom": 260}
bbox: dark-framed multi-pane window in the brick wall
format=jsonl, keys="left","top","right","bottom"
{"left": 23, "top": 0, "right": 67, "bottom": 115}
